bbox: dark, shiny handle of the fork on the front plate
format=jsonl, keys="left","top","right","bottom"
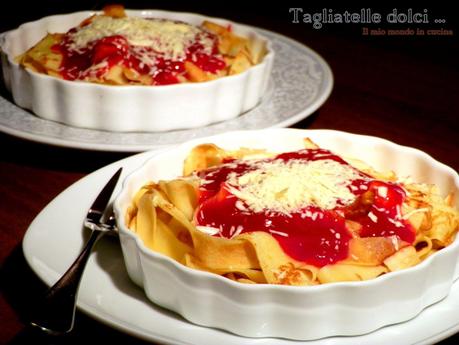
{"left": 30, "top": 230, "right": 105, "bottom": 335}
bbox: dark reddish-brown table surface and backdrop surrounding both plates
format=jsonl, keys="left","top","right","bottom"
{"left": 0, "top": 1, "right": 459, "bottom": 344}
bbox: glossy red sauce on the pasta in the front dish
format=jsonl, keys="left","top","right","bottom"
{"left": 195, "top": 149, "right": 415, "bottom": 267}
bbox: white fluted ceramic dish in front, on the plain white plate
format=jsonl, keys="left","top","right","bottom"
{"left": 114, "top": 129, "right": 459, "bottom": 340}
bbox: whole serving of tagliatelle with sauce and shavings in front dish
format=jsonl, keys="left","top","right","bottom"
{"left": 126, "top": 139, "right": 459, "bottom": 285}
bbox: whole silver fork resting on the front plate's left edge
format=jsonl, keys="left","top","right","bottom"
{"left": 30, "top": 168, "right": 123, "bottom": 335}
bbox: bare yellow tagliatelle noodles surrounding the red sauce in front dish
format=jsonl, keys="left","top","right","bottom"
{"left": 126, "top": 139, "right": 459, "bottom": 285}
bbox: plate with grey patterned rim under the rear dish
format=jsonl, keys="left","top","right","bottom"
{"left": 0, "top": 29, "right": 333, "bottom": 152}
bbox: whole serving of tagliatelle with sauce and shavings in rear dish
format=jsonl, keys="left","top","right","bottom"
{"left": 16, "top": 5, "right": 266, "bottom": 85}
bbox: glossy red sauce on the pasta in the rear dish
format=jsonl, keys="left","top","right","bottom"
{"left": 52, "top": 20, "right": 226, "bottom": 85}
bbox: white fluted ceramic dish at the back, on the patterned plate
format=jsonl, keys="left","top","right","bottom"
{"left": 1, "top": 10, "right": 274, "bottom": 132}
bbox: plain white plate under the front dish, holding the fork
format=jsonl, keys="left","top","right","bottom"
{"left": 23, "top": 143, "right": 459, "bottom": 345}
